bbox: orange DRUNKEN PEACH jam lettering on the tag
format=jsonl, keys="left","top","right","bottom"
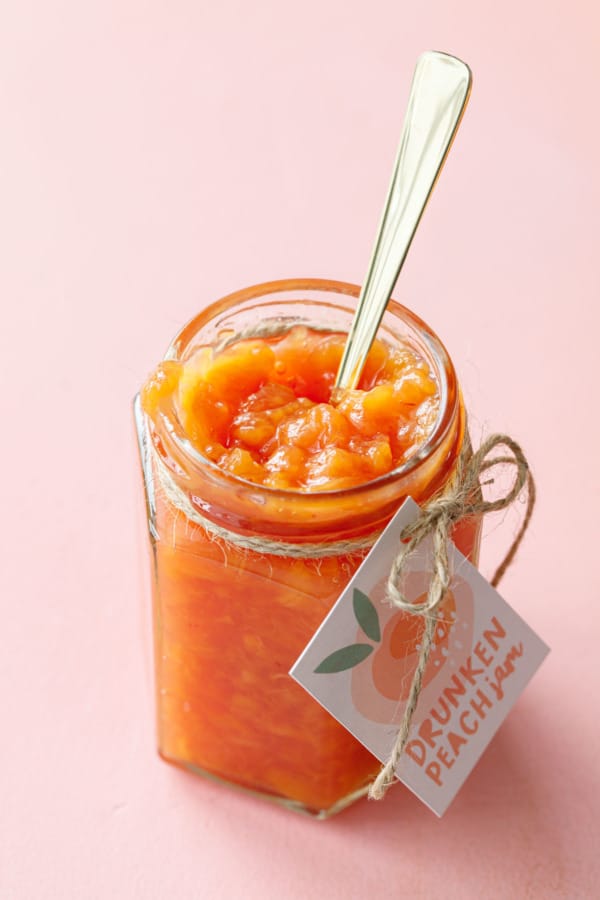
{"left": 404, "top": 616, "right": 523, "bottom": 787}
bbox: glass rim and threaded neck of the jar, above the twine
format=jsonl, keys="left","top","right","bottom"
{"left": 143, "top": 278, "right": 466, "bottom": 543}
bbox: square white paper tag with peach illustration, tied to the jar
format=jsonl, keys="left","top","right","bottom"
{"left": 290, "top": 499, "right": 549, "bottom": 816}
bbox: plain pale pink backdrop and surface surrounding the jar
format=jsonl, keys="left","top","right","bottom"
{"left": 0, "top": 0, "right": 600, "bottom": 900}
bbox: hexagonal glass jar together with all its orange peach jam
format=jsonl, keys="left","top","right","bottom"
{"left": 136, "top": 280, "right": 480, "bottom": 816}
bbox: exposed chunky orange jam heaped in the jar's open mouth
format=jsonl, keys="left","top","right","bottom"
{"left": 143, "top": 326, "right": 439, "bottom": 491}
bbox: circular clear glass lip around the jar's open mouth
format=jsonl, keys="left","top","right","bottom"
{"left": 156, "top": 278, "right": 459, "bottom": 502}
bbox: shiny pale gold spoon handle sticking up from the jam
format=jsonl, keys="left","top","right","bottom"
{"left": 335, "top": 51, "right": 471, "bottom": 388}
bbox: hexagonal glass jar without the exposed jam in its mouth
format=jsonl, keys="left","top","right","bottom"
{"left": 136, "top": 279, "right": 481, "bottom": 818}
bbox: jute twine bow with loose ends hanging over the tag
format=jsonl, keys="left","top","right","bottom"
{"left": 369, "top": 434, "right": 535, "bottom": 800}
